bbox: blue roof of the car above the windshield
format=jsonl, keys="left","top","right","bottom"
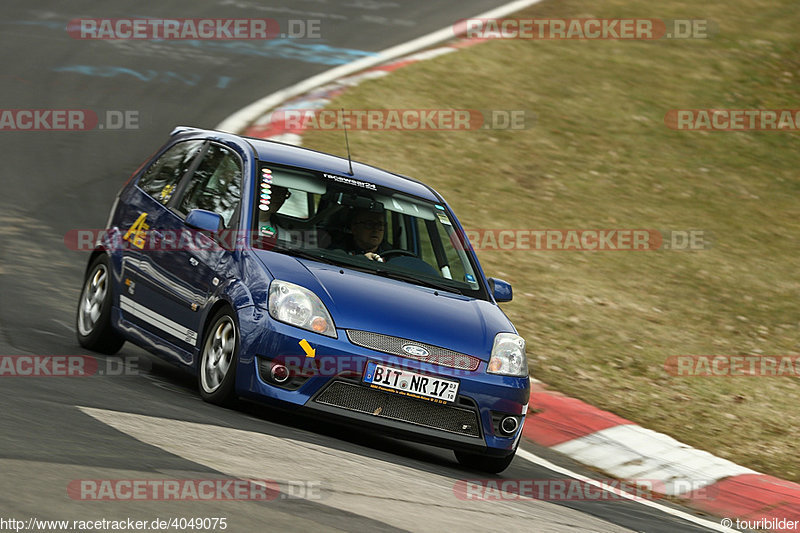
{"left": 171, "top": 126, "right": 443, "bottom": 202}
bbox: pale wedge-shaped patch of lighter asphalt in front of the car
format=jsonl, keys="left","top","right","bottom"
{"left": 80, "top": 407, "right": 629, "bottom": 533}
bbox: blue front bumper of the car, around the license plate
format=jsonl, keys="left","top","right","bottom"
{"left": 236, "top": 308, "right": 530, "bottom": 456}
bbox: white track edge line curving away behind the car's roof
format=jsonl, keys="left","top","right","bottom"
{"left": 214, "top": 0, "right": 542, "bottom": 133}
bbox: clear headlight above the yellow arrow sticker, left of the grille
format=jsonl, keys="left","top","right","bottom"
{"left": 269, "top": 279, "right": 336, "bottom": 338}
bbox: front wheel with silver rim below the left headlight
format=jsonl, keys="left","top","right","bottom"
{"left": 197, "top": 309, "right": 239, "bottom": 406}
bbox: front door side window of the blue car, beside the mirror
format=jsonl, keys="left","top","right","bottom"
{"left": 178, "top": 144, "right": 242, "bottom": 228}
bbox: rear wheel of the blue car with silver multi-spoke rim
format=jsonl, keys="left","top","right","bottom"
{"left": 75, "top": 253, "right": 125, "bottom": 355}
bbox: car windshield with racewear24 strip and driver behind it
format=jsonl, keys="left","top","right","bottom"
{"left": 253, "top": 163, "right": 486, "bottom": 299}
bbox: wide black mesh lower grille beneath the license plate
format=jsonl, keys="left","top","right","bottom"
{"left": 314, "top": 381, "right": 481, "bottom": 437}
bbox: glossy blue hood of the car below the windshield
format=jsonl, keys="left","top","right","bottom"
{"left": 255, "top": 250, "right": 515, "bottom": 361}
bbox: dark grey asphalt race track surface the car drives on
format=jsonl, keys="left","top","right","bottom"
{"left": 0, "top": 0, "right": 713, "bottom": 532}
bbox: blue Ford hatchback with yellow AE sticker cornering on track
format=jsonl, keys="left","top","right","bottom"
{"left": 76, "top": 127, "right": 530, "bottom": 472}
